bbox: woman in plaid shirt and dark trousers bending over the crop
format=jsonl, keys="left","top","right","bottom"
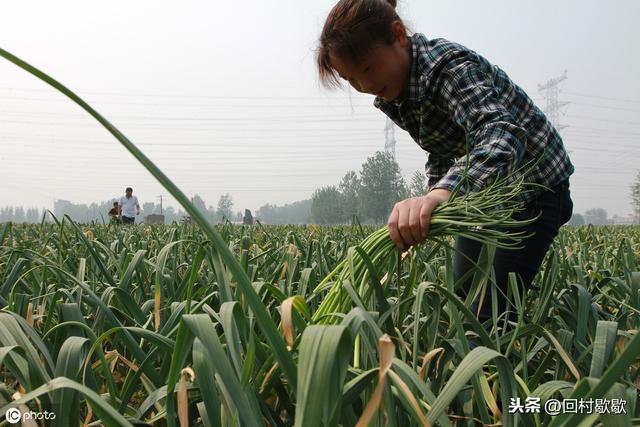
{"left": 317, "top": 0, "right": 574, "bottom": 321}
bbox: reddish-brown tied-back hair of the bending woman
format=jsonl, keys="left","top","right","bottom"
{"left": 317, "top": 0, "right": 402, "bottom": 86}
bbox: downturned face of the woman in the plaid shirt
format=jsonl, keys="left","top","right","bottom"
{"left": 329, "top": 28, "right": 411, "bottom": 101}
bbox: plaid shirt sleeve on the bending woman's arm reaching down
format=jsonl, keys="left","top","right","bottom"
{"left": 427, "top": 57, "right": 526, "bottom": 192}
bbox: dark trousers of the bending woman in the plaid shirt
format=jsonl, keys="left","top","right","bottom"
{"left": 454, "top": 180, "right": 573, "bottom": 323}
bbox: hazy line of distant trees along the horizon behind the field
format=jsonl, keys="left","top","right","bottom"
{"left": 0, "top": 160, "right": 640, "bottom": 225}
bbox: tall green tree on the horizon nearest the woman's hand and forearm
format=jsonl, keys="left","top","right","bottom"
{"left": 360, "top": 151, "right": 408, "bottom": 223}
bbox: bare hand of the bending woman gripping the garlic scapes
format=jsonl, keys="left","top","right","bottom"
{"left": 387, "top": 188, "right": 451, "bottom": 250}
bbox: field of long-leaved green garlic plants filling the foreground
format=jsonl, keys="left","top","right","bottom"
{"left": 0, "top": 218, "right": 640, "bottom": 427}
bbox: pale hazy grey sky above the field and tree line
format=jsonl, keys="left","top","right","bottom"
{"left": 0, "top": 0, "right": 640, "bottom": 219}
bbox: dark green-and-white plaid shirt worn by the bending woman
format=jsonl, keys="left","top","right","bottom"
{"left": 374, "top": 34, "right": 574, "bottom": 201}
